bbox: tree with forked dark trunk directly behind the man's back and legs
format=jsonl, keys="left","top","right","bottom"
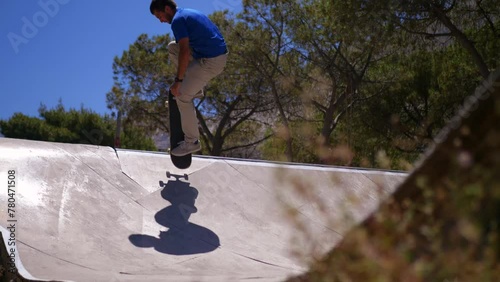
{"left": 196, "top": 12, "right": 272, "bottom": 157}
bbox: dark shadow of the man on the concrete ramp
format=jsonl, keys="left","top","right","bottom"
{"left": 129, "top": 176, "right": 220, "bottom": 256}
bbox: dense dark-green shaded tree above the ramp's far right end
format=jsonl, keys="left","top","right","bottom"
{"left": 351, "top": 46, "right": 478, "bottom": 169}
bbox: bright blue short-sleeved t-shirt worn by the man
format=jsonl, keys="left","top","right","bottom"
{"left": 171, "top": 8, "right": 227, "bottom": 59}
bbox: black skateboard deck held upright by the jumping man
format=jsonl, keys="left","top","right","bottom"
{"left": 168, "top": 91, "right": 193, "bottom": 169}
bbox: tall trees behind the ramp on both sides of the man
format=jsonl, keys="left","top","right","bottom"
{"left": 100, "top": 0, "right": 500, "bottom": 166}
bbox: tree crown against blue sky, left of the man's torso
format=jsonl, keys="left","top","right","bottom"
{"left": 106, "top": 34, "right": 174, "bottom": 134}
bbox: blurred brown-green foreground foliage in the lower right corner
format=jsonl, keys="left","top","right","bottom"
{"left": 288, "top": 98, "right": 500, "bottom": 282}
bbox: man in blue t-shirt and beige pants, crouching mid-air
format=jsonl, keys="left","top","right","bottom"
{"left": 150, "top": 0, "right": 228, "bottom": 156}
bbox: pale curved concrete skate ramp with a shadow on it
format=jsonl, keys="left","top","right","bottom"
{"left": 0, "top": 138, "right": 406, "bottom": 281}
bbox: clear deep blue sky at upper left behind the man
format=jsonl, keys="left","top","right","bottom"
{"left": 0, "top": 0, "right": 242, "bottom": 119}
